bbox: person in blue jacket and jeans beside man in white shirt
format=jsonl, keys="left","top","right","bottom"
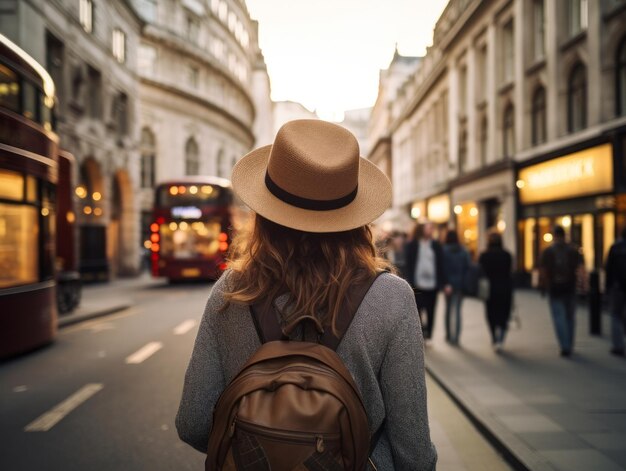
{"left": 443, "top": 230, "right": 471, "bottom": 345}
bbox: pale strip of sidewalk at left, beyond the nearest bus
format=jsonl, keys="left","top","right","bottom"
{"left": 59, "top": 272, "right": 164, "bottom": 328}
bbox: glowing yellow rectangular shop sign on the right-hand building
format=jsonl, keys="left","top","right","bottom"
{"left": 517, "top": 144, "right": 613, "bottom": 204}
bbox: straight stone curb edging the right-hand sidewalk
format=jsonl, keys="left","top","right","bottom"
{"left": 426, "top": 362, "right": 554, "bottom": 471}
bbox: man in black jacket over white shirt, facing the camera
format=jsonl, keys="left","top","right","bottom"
{"left": 405, "top": 222, "right": 445, "bottom": 342}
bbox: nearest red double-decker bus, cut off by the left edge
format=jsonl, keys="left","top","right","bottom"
{"left": 0, "top": 34, "right": 58, "bottom": 357}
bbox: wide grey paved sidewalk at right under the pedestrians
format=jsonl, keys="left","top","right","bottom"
{"left": 426, "top": 291, "right": 626, "bottom": 471}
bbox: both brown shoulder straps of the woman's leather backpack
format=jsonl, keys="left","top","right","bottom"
{"left": 250, "top": 271, "right": 386, "bottom": 350}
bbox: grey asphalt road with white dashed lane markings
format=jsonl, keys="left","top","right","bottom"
{"left": 0, "top": 277, "right": 510, "bottom": 471}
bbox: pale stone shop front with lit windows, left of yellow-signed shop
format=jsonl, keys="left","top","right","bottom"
{"left": 451, "top": 164, "right": 515, "bottom": 260}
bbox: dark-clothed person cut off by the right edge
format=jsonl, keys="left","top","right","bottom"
{"left": 605, "top": 226, "right": 626, "bottom": 357}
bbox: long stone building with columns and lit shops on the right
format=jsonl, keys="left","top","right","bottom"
{"left": 378, "top": 0, "right": 626, "bottom": 281}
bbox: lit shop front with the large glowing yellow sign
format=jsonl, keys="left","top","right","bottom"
{"left": 516, "top": 143, "right": 621, "bottom": 281}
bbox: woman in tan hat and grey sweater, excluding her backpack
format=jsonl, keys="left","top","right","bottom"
{"left": 176, "top": 120, "right": 437, "bottom": 470}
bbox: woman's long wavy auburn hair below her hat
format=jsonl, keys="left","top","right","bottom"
{"left": 225, "top": 214, "right": 392, "bottom": 332}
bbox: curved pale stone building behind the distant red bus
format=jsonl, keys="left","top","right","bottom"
{"left": 134, "top": 0, "right": 271, "bottom": 243}
